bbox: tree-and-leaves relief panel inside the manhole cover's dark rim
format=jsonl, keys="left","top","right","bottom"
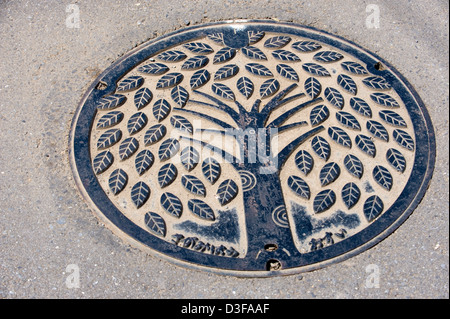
{"left": 90, "top": 29, "right": 416, "bottom": 258}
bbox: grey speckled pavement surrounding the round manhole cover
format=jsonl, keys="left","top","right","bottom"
{"left": 0, "top": 0, "right": 449, "bottom": 299}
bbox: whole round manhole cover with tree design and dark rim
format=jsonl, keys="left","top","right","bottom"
{"left": 70, "top": 21, "right": 435, "bottom": 276}
